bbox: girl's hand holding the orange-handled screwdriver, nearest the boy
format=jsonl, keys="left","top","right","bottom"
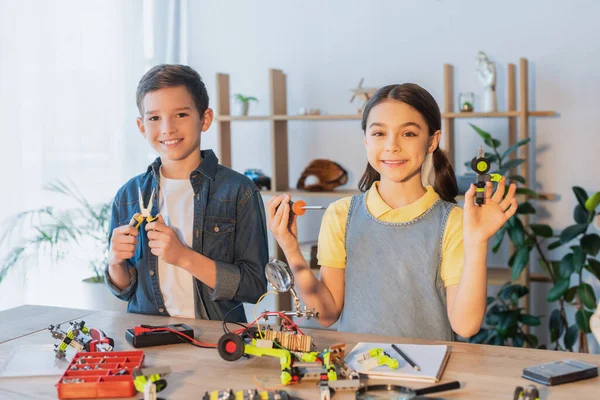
{"left": 266, "top": 194, "right": 298, "bottom": 253}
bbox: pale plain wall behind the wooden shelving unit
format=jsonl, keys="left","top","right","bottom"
{"left": 188, "top": 0, "right": 600, "bottom": 350}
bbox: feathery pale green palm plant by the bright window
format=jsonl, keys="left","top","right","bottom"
{"left": 0, "top": 181, "right": 111, "bottom": 283}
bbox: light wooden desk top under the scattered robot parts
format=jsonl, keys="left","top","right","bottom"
{"left": 0, "top": 306, "right": 600, "bottom": 400}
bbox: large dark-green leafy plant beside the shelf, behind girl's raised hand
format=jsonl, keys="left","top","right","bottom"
{"left": 465, "top": 124, "right": 600, "bottom": 353}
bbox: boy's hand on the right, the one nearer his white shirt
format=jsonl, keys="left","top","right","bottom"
{"left": 146, "top": 214, "right": 188, "bottom": 267}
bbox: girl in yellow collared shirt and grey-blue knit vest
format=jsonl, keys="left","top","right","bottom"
{"left": 267, "top": 83, "right": 517, "bottom": 340}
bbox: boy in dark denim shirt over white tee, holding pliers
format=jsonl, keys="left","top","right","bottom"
{"left": 105, "top": 65, "right": 268, "bottom": 322}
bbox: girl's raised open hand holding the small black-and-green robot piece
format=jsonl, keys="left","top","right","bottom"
{"left": 463, "top": 177, "right": 517, "bottom": 245}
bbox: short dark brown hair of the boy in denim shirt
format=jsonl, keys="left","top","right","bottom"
{"left": 135, "top": 64, "right": 208, "bottom": 118}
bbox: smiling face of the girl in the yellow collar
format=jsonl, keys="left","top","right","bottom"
{"left": 365, "top": 99, "right": 440, "bottom": 187}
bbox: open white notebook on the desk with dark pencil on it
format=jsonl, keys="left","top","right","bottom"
{"left": 345, "top": 342, "right": 450, "bottom": 382}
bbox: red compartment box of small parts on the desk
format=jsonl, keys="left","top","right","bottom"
{"left": 56, "top": 350, "right": 144, "bottom": 399}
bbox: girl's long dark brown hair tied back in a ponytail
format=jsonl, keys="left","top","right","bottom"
{"left": 358, "top": 83, "right": 458, "bottom": 203}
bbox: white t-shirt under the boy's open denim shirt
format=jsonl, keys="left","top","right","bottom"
{"left": 158, "top": 170, "right": 196, "bottom": 318}
